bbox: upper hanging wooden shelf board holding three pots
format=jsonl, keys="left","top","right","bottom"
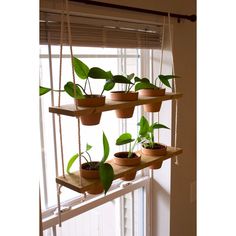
{"left": 49, "top": 93, "right": 182, "bottom": 117}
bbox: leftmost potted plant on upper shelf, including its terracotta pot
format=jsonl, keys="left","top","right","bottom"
{"left": 40, "top": 57, "right": 114, "bottom": 125}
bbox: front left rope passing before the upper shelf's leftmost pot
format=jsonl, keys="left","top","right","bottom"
{"left": 66, "top": 0, "right": 82, "bottom": 183}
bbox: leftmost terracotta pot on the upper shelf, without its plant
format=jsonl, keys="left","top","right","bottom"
{"left": 76, "top": 95, "right": 106, "bottom": 125}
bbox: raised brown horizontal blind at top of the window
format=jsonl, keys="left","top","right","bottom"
{"left": 40, "top": 12, "right": 162, "bottom": 49}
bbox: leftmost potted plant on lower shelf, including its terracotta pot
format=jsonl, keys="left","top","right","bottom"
{"left": 66, "top": 132, "right": 114, "bottom": 194}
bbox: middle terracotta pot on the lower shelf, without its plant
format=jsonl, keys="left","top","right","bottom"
{"left": 113, "top": 152, "right": 141, "bottom": 181}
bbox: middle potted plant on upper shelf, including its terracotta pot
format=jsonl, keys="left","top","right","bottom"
{"left": 110, "top": 74, "right": 138, "bottom": 118}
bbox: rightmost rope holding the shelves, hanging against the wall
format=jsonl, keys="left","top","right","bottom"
{"left": 168, "top": 13, "right": 179, "bottom": 165}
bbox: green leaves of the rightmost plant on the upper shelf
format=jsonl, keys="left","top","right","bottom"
{"left": 135, "top": 75, "right": 180, "bottom": 91}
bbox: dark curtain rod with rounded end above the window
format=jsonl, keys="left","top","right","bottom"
{"left": 70, "top": 0, "right": 197, "bottom": 22}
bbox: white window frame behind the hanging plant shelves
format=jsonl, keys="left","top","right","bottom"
{"left": 40, "top": 49, "right": 157, "bottom": 236}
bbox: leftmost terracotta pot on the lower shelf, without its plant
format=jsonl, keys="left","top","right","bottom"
{"left": 80, "top": 161, "right": 104, "bottom": 194}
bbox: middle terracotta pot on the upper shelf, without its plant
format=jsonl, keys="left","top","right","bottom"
{"left": 110, "top": 91, "right": 138, "bottom": 118}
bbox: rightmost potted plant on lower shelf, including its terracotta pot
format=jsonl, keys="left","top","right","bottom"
{"left": 138, "top": 116, "right": 169, "bottom": 169}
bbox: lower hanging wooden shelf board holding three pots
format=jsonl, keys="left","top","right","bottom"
{"left": 56, "top": 147, "right": 183, "bottom": 193}
